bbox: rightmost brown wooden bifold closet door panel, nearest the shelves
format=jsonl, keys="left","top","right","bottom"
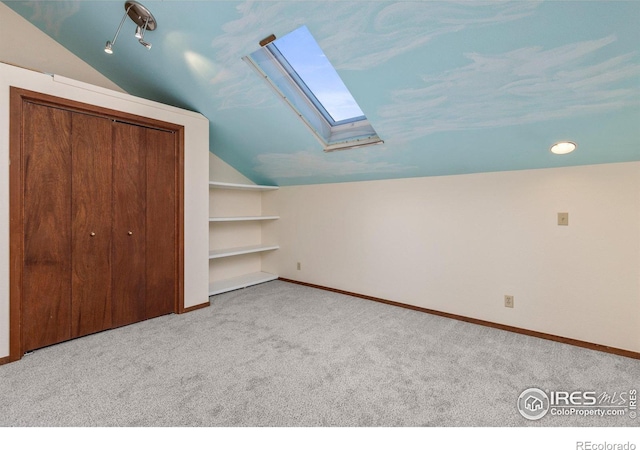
{"left": 145, "top": 128, "right": 178, "bottom": 319}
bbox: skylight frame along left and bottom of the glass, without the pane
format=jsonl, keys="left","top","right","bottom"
{"left": 242, "top": 26, "right": 384, "bottom": 152}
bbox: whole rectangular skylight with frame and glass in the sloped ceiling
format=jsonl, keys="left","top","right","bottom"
{"left": 243, "top": 26, "right": 382, "bottom": 151}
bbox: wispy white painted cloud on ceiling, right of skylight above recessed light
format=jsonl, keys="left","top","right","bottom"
{"left": 378, "top": 35, "right": 640, "bottom": 139}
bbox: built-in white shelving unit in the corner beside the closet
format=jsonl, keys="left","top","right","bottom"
{"left": 209, "top": 181, "right": 280, "bottom": 296}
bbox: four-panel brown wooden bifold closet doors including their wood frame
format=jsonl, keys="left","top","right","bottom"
{"left": 9, "top": 87, "right": 184, "bottom": 361}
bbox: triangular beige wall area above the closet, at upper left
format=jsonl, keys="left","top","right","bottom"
{"left": 0, "top": 3, "right": 124, "bottom": 92}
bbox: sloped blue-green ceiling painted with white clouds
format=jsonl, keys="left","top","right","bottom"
{"left": 4, "top": 0, "right": 640, "bottom": 186}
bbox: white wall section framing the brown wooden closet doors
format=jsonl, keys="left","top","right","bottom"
{"left": 0, "top": 64, "right": 209, "bottom": 357}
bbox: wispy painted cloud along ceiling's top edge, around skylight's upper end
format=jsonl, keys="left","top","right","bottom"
{"left": 211, "top": 1, "right": 539, "bottom": 110}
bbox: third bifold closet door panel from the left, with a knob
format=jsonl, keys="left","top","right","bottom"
{"left": 112, "top": 122, "right": 147, "bottom": 327}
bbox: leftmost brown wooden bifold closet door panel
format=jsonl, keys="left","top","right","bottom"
{"left": 21, "top": 102, "right": 71, "bottom": 351}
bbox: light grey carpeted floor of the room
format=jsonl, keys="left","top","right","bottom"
{"left": 0, "top": 281, "right": 640, "bottom": 427}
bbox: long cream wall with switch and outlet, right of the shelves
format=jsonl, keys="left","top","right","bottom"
{"left": 263, "top": 162, "right": 640, "bottom": 352}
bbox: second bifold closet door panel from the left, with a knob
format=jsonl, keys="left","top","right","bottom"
{"left": 71, "top": 114, "right": 112, "bottom": 337}
